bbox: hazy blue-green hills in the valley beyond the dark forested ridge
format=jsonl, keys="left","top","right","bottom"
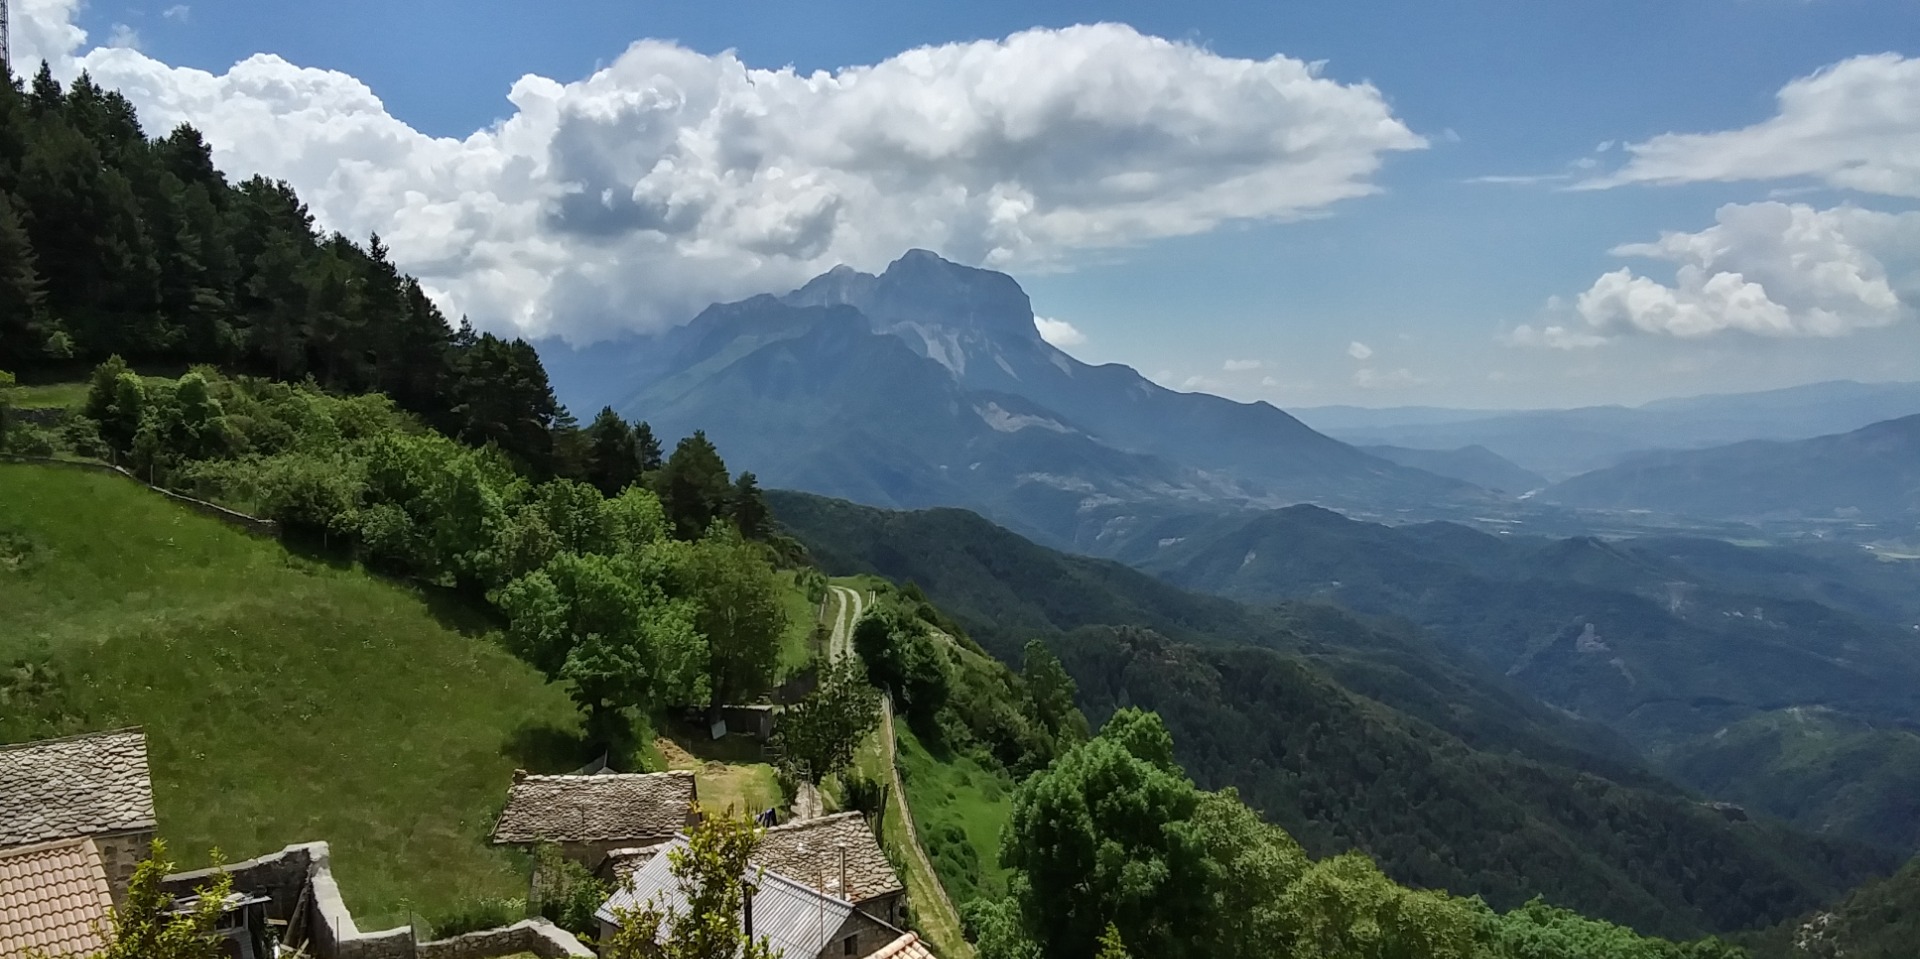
{"left": 1082, "top": 507, "right": 1920, "bottom": 849}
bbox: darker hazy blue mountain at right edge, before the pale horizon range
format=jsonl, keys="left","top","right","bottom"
{"left": 1542, "top": 415, "right": 1920, "bottom": 519}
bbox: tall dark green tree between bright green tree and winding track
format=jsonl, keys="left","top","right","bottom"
{"left": 684, "top": 527, "right": 787, "bottom": 707}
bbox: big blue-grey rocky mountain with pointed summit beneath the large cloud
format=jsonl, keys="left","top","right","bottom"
{"left": 553, "top": 250, "right": 1490, "bottom": 548}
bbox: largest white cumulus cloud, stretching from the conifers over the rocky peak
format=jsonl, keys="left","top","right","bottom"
{"left": 15, "top": 0, "right": 1427, "bottom": 338}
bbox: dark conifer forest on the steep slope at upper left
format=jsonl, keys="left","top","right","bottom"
{"left": 0, "top": 67, "right": 564, "bottom": 475}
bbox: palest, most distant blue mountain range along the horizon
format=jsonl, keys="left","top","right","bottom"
{"left": 1294, "top": 381, "right": 1920, "bottom": 480}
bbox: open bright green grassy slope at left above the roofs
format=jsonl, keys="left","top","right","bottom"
{"left": 0, "top": 465, "right": 582, "bottom": 928}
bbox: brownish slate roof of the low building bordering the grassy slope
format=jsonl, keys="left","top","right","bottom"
{"left": 493, "top": 771, "right": 697, "bottom": 842}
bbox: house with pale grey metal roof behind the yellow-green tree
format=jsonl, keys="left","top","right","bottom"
{"left": 593, "top": 838, "right": 906, "bottom": 959}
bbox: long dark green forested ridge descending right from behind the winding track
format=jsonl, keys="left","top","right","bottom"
{"left": 770, "top": 492, "right": 1891, "bottom": 934}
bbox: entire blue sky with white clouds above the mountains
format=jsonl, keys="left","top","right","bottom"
{"left": 12, "top": 0, "right": 1920, "bottom": 407}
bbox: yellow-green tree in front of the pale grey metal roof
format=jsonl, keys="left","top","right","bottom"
{"left": 601, "top": 815, "right": 780, "bottom": 959}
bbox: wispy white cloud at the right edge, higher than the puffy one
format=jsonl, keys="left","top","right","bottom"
{"left": 1584, "top": 54, "right": 1920, "bottom": 196}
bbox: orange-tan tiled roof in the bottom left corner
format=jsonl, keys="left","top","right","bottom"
{"left": 0, "top": 838, "right": 113, "bottom": 959}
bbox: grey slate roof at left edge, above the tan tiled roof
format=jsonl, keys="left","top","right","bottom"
{"left": 0, "top": 728, "right": 154, "bottom": 848}
